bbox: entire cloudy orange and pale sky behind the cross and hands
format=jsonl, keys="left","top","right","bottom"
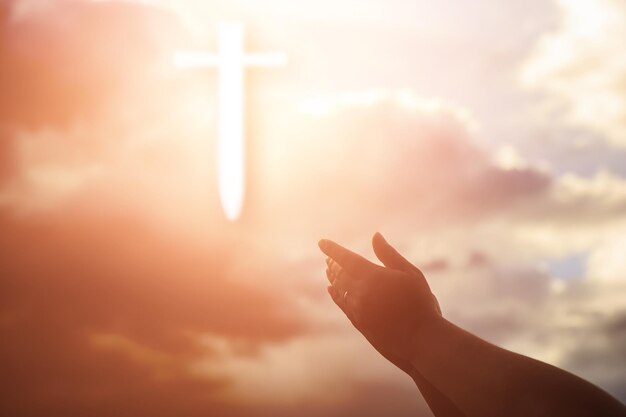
{"left": 0, "top": 0, "right": 626, "bottom": 417}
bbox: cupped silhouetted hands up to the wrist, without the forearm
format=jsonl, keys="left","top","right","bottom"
{"left": 319, "top": 233, "right": 441, "bottom": 373}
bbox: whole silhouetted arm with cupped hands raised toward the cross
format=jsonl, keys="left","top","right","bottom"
{"left": 320, "top": 234, "right": 626, "bottom": 417}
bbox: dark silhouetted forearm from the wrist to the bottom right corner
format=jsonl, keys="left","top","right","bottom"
{"left": 411, "top": 319, "right": 626, "bottom": 417}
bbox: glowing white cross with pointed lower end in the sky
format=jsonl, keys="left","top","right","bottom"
{"left": 176, "top": 23, "right": 287, "bottom": 220}
